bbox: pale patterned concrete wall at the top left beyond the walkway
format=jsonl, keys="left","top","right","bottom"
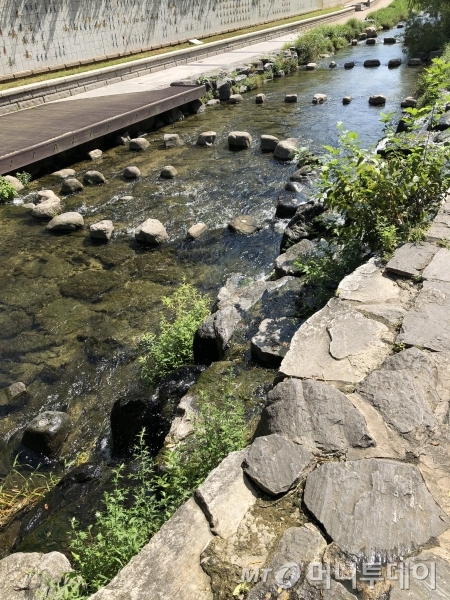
{"left": 0, "top": 0, "right": 342, "bottom": 75}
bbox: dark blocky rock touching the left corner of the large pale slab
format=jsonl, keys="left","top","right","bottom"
{"left": 251, "top": 317, "right": 301, "bottom": 368}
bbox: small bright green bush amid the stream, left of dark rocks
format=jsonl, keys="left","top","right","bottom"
{"left": 139, "top": 282, "right": 209, "bottom": 385}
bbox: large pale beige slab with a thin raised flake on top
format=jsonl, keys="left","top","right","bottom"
{"left": 280, "top": 295, "right": 393, "bottom": 391}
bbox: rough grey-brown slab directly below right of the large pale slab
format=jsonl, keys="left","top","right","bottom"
{"left": 358, "top": 348, "right": 441, "bottom": 434}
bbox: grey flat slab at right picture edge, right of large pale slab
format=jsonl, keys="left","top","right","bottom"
{"left": 397, "top": 281, "right": 450, "bottom": 352}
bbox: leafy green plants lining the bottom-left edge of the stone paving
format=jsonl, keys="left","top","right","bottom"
{"left": 67, "top": 373, "right": 247, "bottom": 600}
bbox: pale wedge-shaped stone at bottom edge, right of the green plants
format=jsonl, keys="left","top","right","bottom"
{"left": 90, "top": 498, "right": 213, "bottom": 600}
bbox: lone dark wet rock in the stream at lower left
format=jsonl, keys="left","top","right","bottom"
{"left": 22, "top": 410, "right": 71, "bottom": 458}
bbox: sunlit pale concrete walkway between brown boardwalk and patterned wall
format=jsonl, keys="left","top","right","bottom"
{"left": 61, "top": 0, "right": 398, "bottom": 102}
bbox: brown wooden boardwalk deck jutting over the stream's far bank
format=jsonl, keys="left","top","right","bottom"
{"left": 0, "top": 85, "right": 205, "bottom": 174}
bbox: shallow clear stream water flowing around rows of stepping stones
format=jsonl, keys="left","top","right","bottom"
{"left": 0, "top": 30, "right": 418, "bottom": 548}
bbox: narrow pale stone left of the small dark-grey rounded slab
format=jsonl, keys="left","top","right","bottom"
{"left": 194, "top": 450, "right": 257, "bottom": 539}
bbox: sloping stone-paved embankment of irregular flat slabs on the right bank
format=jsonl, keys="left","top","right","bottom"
{"left": 71, "top": 195, "right": 450, "bottom": 600}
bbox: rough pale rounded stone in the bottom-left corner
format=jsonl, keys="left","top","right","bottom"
{"left": 0, "top": 552, "right": 72, "bottom": 600}
